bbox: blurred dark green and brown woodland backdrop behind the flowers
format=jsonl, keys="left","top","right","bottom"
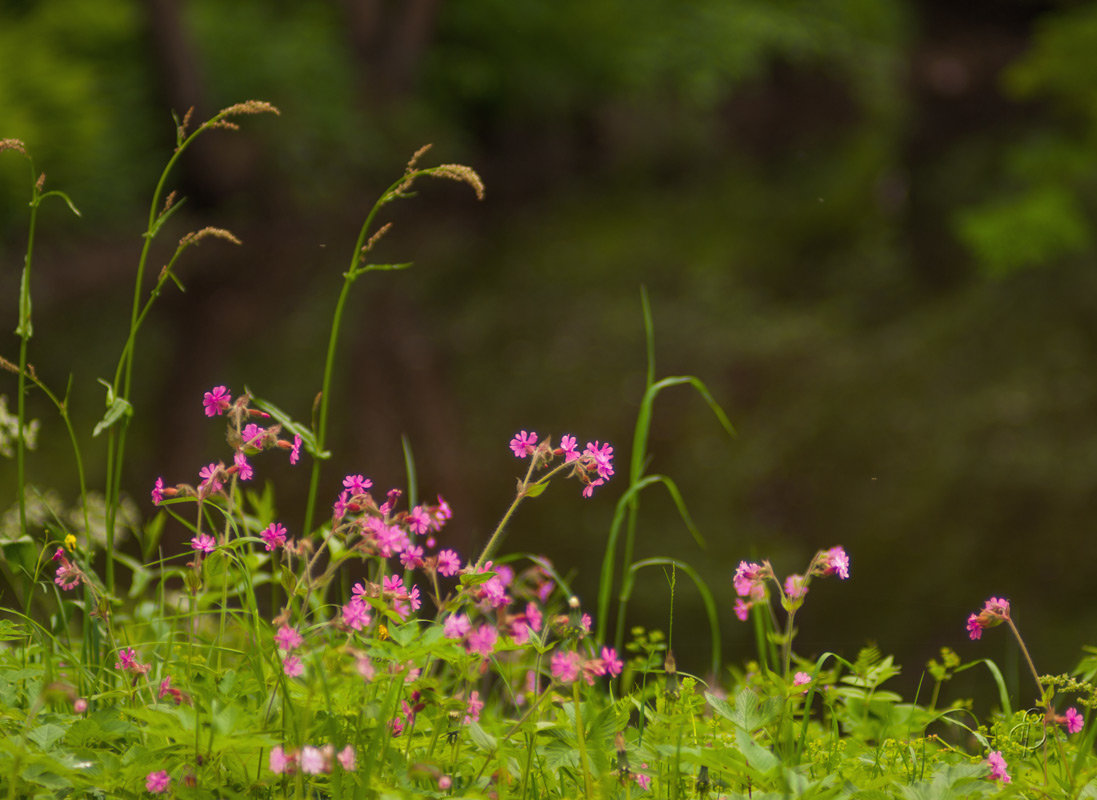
{"left": 0, "top": 0, "right": 1097, "bottom": 686}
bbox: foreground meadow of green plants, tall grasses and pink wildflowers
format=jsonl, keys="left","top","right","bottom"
{"left": 0, "top": 107, "right": 1097, "bottom": 800}
